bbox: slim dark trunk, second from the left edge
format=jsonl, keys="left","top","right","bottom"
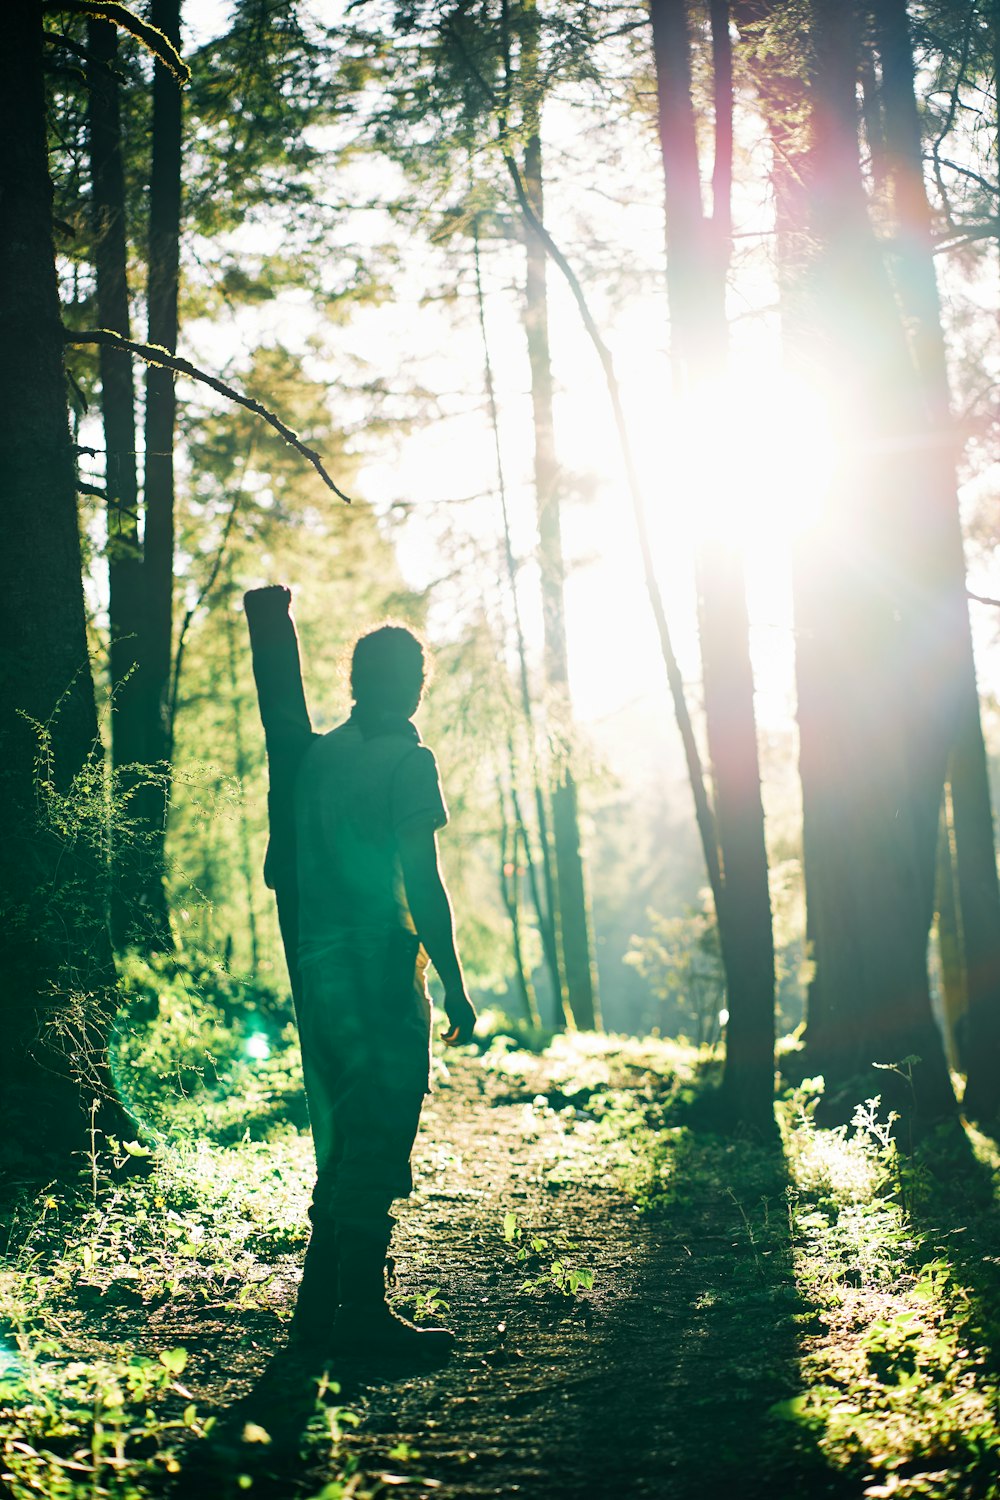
{"left": 87, "top": 21, "right": 147, "bottom": 947}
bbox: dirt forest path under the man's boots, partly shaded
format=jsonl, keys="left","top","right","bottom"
{"left": 171, "top": 1055, "right": 846, "bottom": 1500}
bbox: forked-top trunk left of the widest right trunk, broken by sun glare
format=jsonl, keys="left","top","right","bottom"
{"left": 651, "top": 0, "right": 775, "bottom": 1130}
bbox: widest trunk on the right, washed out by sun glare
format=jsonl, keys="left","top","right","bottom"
{"left": 735, "top": 0, "right": 954, "bottom": 1116}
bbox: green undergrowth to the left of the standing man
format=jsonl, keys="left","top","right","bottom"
{"left": 0, "top": 954, "right": 353, "bottom": 1500}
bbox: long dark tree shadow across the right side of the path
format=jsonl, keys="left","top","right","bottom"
{"left": 530, "top": 1127, "right": 858, "bottom": 1500}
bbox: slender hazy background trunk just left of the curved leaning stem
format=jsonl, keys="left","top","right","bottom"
{"left": 520, "top": 17, "right": 600, "bottom": 1029}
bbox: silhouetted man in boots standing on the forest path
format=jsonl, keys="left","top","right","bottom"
{"left": 292, "top": 626, "right": 475, "bottom": 1355}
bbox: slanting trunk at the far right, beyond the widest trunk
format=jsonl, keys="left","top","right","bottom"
{"left": 874, "top": 0, "right": 1000, "bottom": 1119}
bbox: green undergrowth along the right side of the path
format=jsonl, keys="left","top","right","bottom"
{"left": 607, "top": 1062, "right": 1000, "bottom": 1500}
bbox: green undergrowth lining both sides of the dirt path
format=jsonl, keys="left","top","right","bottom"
{"left": 0, "top": 1008, "right": 1000, "bottom": 1500}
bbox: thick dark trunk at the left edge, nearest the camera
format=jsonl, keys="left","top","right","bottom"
{"left": 0, "top": 5, "right": 128, "bottom": 1166}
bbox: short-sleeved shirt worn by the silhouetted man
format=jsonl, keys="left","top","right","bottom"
{"left": 295, "top": 720, "right": 448, "bottom": 954}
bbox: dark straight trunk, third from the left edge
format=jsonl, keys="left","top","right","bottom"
{"left": 142, "top": 0, "right": 181, "bottom": 942}
